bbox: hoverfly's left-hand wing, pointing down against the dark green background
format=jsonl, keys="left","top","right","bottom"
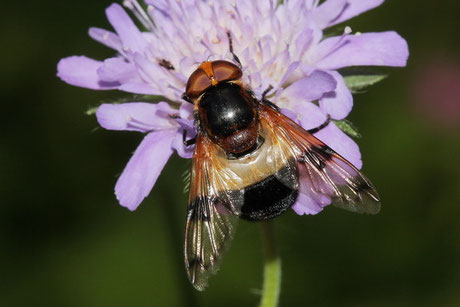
{"left": 184, "top": 135, "right": 243, "bottom": 290}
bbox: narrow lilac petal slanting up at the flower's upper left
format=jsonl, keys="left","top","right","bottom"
{"left": 105, "top": 3, "right": 147, "bottom": 52}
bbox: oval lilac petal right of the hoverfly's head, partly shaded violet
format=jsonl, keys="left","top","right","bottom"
{"left": 281, "top": 70, "right": 337, "bottom": 102}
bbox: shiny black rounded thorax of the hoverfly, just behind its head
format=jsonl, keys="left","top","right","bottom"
{"left": 199, "top": 82, "right": 256, "bottom": 137}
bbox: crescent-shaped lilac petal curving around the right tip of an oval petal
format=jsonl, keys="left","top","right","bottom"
{"left": 319, "top": 71, "right": 353, "bottom": 120}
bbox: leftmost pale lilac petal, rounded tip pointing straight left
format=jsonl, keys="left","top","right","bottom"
{"left": 57, "top": 56, "right": 120, "bottom": 90}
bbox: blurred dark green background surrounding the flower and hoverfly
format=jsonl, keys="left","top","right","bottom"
{"left": 0, "top": 0, "right": 460, "bottom": 307}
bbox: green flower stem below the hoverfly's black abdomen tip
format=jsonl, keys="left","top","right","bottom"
{"left": 260, "top": 221, "right": 281, "bottom": 307}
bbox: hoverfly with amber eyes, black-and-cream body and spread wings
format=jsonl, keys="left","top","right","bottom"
{"left": 183, "top": 36, "right": 380, "bottom": 290}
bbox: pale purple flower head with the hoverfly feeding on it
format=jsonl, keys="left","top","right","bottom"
{"left": 58, "top": 0, "right": 408, "bottom": 214}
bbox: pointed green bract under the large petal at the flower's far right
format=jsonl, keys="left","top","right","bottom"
{"left": 339, "top": 67, "right": 389, "bottom": 93}
